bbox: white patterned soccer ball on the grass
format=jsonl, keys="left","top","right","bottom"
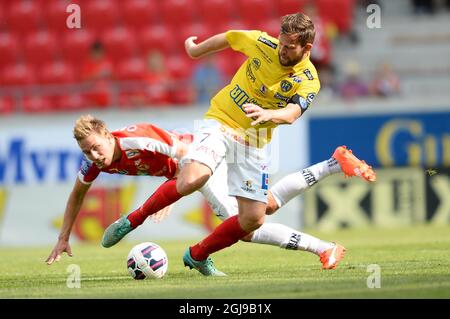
{"left": 127, "top": 242, "right": 169, "bottom": 279}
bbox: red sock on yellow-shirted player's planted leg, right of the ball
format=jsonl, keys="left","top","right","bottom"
{"left": 191, "top": 215, "right": 249, "bottom": 260}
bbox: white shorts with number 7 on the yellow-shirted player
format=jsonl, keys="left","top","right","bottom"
{"left": 182, "top": 119, "right": 269, "bottom": 203}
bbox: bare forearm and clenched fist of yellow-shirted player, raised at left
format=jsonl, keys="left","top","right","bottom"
{"left": 184, "top": 33, "right": 230, "bottom": 59}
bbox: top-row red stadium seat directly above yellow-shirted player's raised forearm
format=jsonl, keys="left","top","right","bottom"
{"left": 199, "top": 0, "right": 235, "bottom": 29}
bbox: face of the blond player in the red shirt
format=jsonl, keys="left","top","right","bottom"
{"left": 78, "top": 134, "right": 115, "bottom": 169}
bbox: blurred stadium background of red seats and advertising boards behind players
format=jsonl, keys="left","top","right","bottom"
{"left": 0, "top": 0, "right": 450, "bottom": 276}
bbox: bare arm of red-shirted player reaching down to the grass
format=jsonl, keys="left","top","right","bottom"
{"left": 45, "top": 178, "right": 90, "bottom": 265}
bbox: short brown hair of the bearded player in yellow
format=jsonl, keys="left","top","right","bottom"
{"left": 280, "top": 12, "right": 316, "bottom": 47}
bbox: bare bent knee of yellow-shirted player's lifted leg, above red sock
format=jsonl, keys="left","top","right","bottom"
{"left": 177, "top": 161, "right": 212, "bottom": 196}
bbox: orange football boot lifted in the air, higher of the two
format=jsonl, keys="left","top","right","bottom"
{"left": 333, "top": 146, "right": 377, "bottom": 182}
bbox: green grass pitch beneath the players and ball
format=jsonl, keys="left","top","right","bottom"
{"left": 0, "top": 226, "right": 450, "bottom": 299}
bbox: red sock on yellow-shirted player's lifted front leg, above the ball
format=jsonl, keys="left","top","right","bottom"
{"left": 127, "top": 178, "right": 183, "bottom": 228}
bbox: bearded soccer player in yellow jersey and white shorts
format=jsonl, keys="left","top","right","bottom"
{"left": 176, "top": 13, "right": 345, "bottom": 276}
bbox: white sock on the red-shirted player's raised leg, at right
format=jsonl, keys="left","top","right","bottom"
{"left": 270, "top": 158, "right": 342, "bottom": 207}
